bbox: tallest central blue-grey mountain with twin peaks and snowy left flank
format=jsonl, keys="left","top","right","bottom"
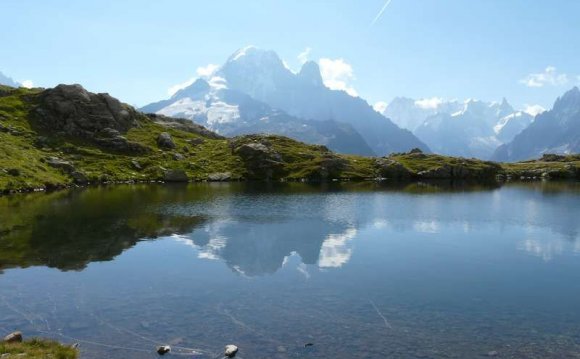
{"left": 142, "top": 47, "right": 428, "bottom": 155}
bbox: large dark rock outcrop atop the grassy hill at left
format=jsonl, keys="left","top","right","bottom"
{"left": 33, "top": 85, "right": 147, "bottom": 153}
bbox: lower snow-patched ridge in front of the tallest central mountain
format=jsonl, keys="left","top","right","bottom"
{"left": 141, "top": 77, "right": 374, "bottom": 156}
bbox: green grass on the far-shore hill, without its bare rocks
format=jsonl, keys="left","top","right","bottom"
{"left": 0, "top": 86, "right": 580, "bottom": 192}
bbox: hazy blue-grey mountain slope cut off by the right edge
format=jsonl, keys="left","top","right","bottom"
{"left": 493, "top": 87, "right": 580, "bottom": 161}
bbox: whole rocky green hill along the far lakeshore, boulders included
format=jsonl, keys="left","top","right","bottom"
{"left": 0, "top": 85, "right": 579, "bottom": 193}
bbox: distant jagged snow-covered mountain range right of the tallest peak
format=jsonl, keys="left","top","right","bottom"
{"left": 383, "top": 97, "right": 533, "bottom": 159}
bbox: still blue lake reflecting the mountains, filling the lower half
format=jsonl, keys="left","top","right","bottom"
{"left": 0, "top": 183, "right": 580, "bottom": 359}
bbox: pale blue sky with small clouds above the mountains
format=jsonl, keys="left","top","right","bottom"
{"left": 0, "top": 0, "right": 580, "bottom": 111}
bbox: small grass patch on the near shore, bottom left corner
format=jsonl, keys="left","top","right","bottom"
{"left": 0, "top": 338, "right": 78, "bottom": 359}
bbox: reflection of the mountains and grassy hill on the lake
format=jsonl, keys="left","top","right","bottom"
{"left": 0, "top": 182, "right": 580, "bottom": 276}
